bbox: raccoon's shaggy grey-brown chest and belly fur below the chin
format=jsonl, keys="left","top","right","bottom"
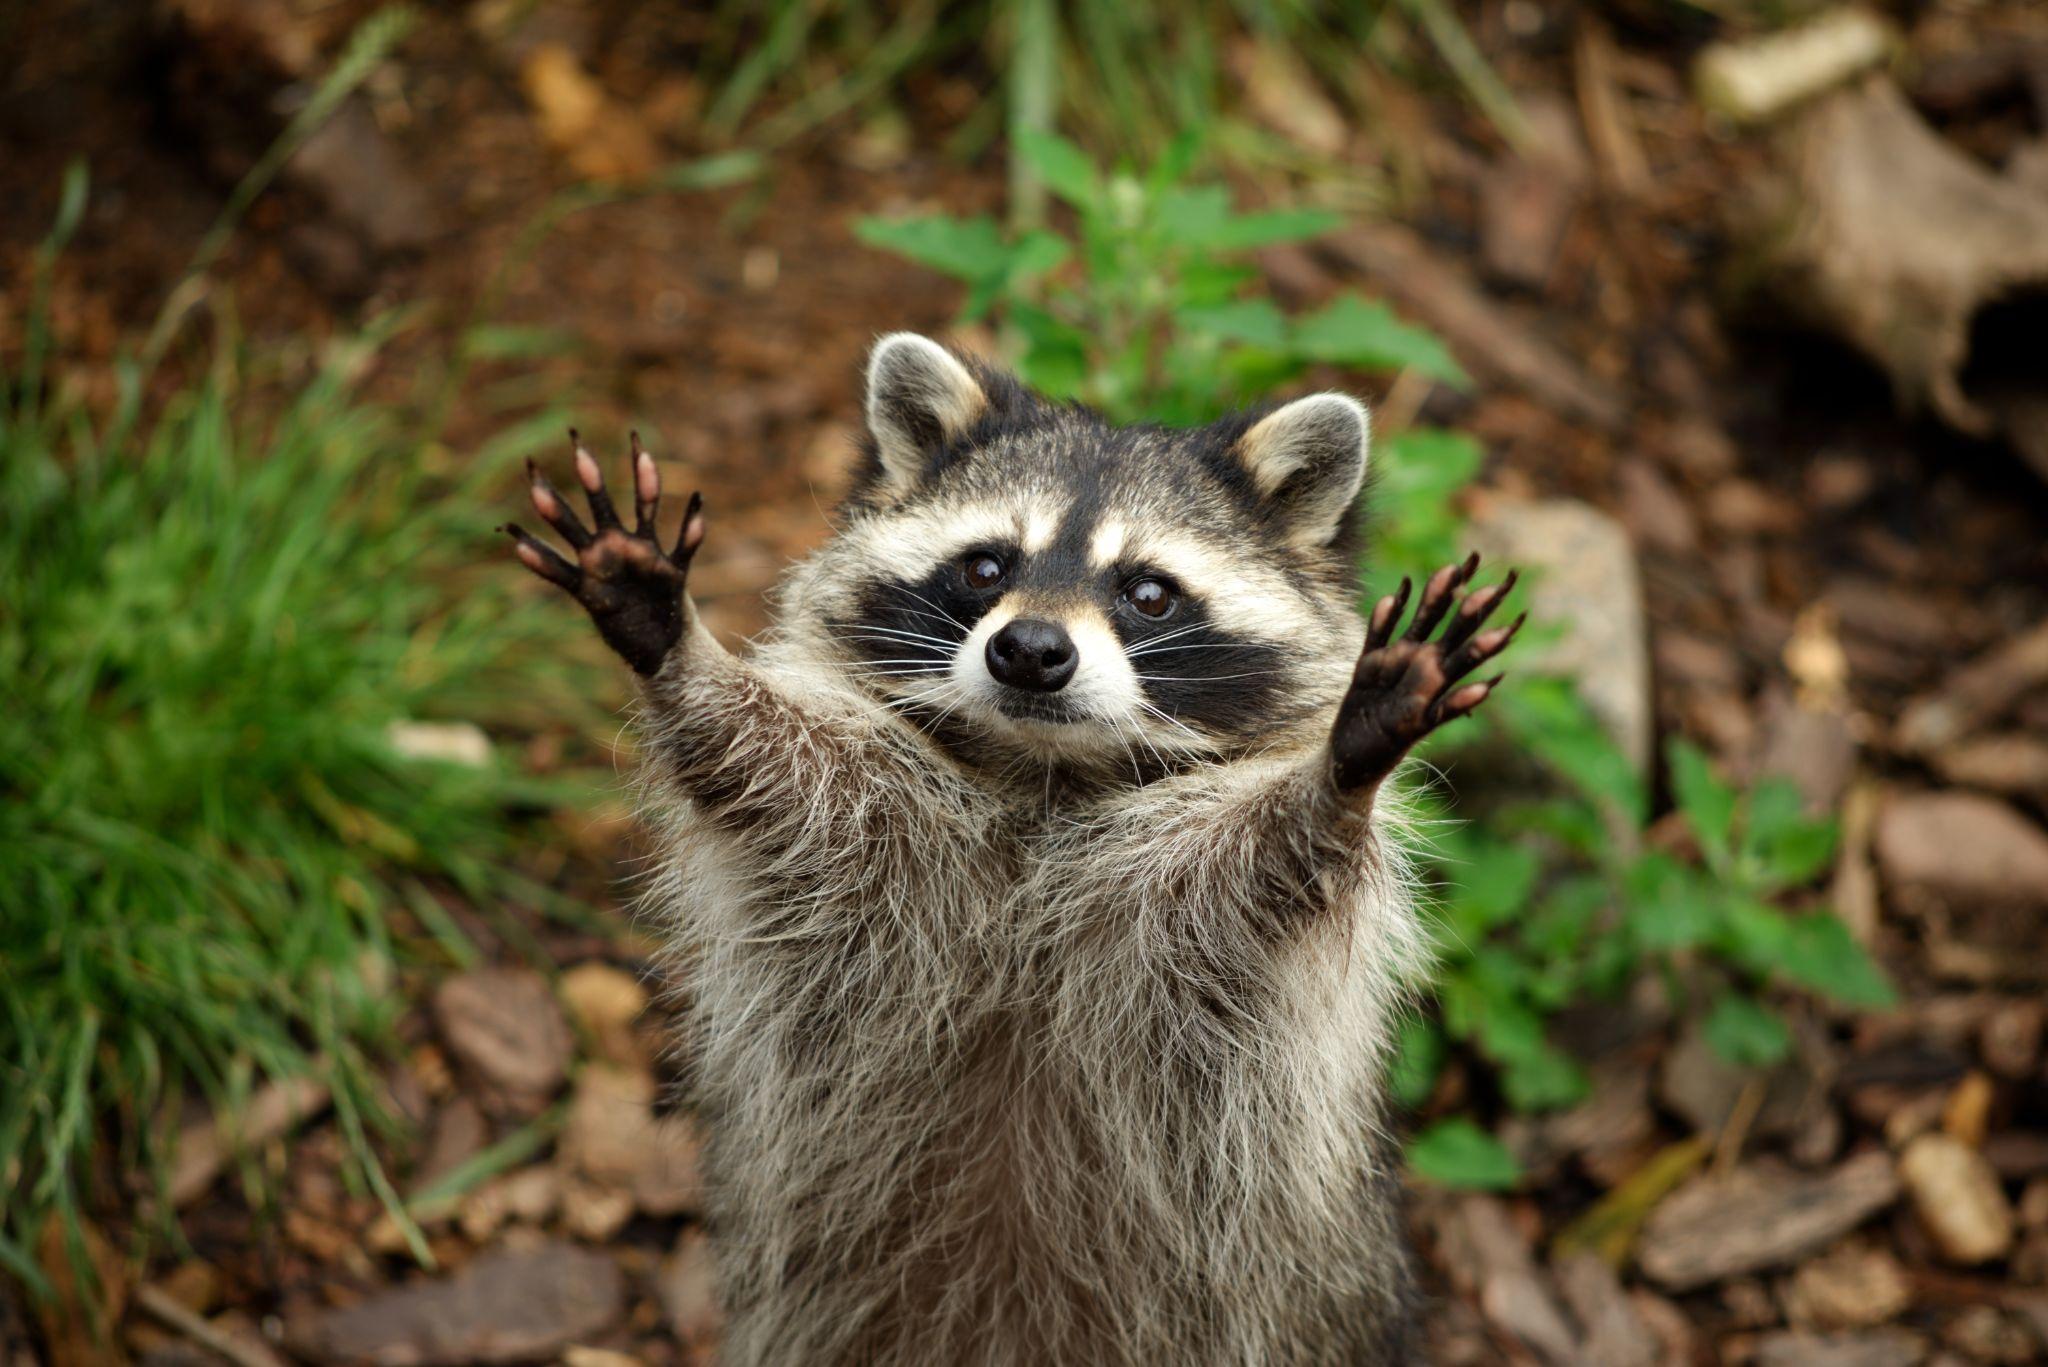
{"left": 655, "top": 717, "right": 1401, "bottom": 1363}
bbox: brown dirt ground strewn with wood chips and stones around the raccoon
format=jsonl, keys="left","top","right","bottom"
{"left": 0, "top": 0, "right": 2048, "bottom": 1367}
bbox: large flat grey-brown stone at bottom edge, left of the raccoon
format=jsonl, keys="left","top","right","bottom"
{"left": 285, "top": 1240, "right": 625, "bottom": 1367}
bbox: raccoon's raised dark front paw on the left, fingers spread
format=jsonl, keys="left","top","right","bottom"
{"left": 502, "top": 428, "right": 705, "bottom": 674}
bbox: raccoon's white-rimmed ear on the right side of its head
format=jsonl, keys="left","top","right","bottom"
{"left": 1237, "top": 393, "right": 1372, "bottom": 547}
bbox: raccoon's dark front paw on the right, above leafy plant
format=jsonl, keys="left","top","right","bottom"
{"left": 1329, "top": 553, "right": 1528, "bottom": 791}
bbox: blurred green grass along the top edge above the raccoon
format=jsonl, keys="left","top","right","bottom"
{"left": 696, "top": 0, "right": 1528, "bottom": 176}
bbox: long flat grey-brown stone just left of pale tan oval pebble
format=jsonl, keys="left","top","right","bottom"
{"left": 1636, "top": 1152, "right": 1898, "bottom": 1291}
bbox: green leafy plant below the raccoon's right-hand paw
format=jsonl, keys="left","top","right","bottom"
{"left": 1395, "top": 696, "right": 1892, "bottom": 1111}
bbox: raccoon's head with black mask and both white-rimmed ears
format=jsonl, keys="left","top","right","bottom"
{"left": 791, "top": 334, "right": 1368, "bottom": 777}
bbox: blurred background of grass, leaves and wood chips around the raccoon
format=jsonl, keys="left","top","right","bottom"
{"left": 0, "top": 0, "right": 2048, "bottom": 1367}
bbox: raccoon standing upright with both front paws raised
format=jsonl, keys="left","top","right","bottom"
{"left": 506, "top": 334, "right": 1522, "bottom": 1365}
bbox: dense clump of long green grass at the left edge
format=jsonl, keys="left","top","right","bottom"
{"left": 0, "top": 170, "right": 602, "bottom": 1285}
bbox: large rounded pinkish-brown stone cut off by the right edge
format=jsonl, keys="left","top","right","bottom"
{"left": 1876, "top": 793, "right": 2048, "bottom": 908}
